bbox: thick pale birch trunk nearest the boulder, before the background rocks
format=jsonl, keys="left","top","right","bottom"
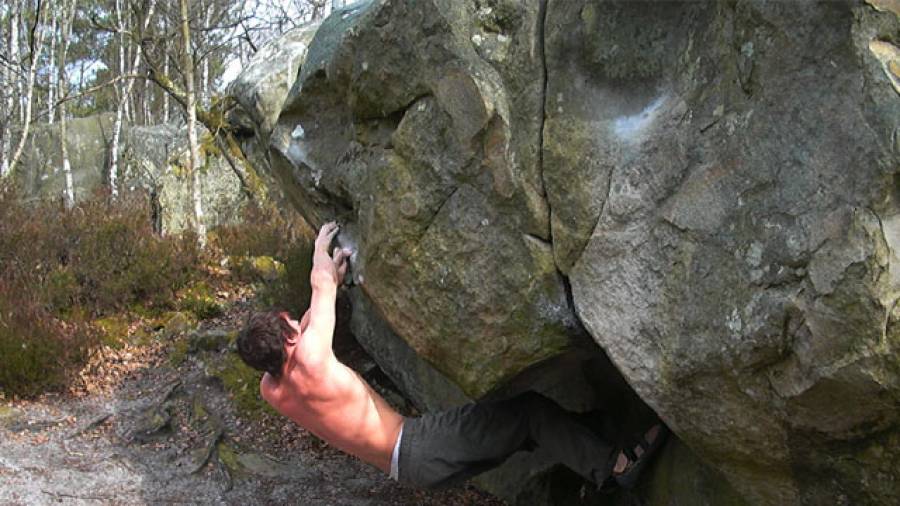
{"left": 180, "top": 0, "right": 206, "bottom": 248}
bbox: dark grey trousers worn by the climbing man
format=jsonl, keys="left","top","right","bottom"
{"left": 398, "top": 392, "right": 615, "bottom": 488}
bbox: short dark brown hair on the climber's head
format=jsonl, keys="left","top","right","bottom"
{"left": 237, "top": 310, "right": 294, "bottom": 378}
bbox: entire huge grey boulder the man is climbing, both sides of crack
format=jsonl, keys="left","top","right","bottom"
{"left": 234, "top": 0, "right": 900, "bottom": 504}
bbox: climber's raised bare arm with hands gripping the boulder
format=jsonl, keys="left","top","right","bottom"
{"left": 299, "top": 222, "right": 349, "bottom": 369}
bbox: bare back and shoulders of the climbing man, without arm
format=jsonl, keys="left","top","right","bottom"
{"left": 260, "top": 346, "right": 403, "bottom": 473}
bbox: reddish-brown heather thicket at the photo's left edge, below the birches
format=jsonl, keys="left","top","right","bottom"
{"left": 0, "top": 187, "right": 201, "bottom": 395}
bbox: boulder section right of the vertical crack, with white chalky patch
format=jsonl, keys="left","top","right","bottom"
{"left": 556, "top": 2, "right": 900, "bottom": 504}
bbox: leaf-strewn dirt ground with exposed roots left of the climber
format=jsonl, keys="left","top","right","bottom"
{"left": 0, "top": 286, "right": 503, "bottom": 506}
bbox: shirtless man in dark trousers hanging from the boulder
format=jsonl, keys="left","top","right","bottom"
{"left": 237, "top": 223, "right": 665, "bottom": 488}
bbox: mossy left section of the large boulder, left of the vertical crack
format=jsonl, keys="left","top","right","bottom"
{"left": 272, "top": 2, "right": 575, "bottom": 396}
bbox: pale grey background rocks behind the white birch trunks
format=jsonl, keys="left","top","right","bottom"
{"left": 13, "top": 114, "right": 246, "bottom": 233}
